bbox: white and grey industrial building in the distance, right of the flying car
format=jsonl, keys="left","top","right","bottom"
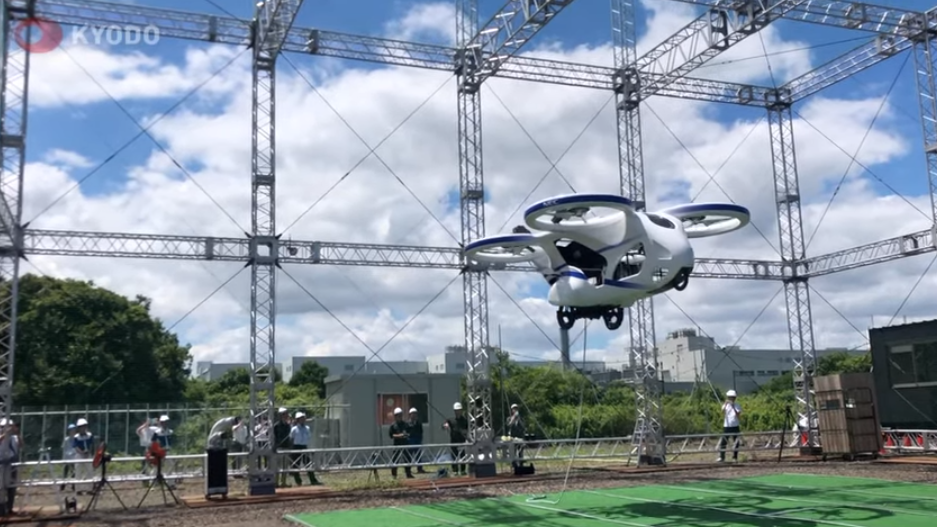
{"left": 658, "top": 329, "right": 867, "bottom": 393}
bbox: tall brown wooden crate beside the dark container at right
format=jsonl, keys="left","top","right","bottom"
{"left": 814, "top": 373, "right": 882, "bottom": 455}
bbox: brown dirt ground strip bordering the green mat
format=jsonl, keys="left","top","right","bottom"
{"left": 11, "top": 462, "right": 937, "bottom": 527}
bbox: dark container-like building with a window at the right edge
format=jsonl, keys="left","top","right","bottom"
{"left": 869, "top": 320, "right": 937, "bottom": 429}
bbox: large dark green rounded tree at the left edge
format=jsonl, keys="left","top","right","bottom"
{"left": 6, "top": 275, "right": 192, "bottom": 405}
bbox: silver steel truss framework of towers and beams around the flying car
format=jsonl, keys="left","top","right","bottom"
{"left": 0, "top": 0, "right": 937, "bottom": 476}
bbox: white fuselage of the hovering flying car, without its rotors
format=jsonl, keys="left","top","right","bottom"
{"left": 535, "top": 207, "right": 694, "bottom": 307}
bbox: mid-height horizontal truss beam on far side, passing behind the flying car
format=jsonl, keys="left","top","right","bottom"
{"left": 23, "top": 229, "right": 790, "bottom": 280}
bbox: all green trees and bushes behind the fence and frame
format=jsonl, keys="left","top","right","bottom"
{"left": 0, "top": 275, "right": 871, "bottom": 451}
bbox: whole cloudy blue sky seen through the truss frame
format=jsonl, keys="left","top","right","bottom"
{"left": 12, "top": 0, "right": 937, "bottom": 374}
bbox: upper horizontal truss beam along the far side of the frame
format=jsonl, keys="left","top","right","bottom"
{"left": 23, "top": 0, "right": 784, "bottom": 106}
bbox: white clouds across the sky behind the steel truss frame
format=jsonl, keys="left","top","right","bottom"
{"left": 16, "top": 4, "right": 937, "bottom": 376}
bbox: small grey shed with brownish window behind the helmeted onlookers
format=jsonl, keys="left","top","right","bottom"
{"left": 325, "top": 373, "right": 462, "bottom": 447}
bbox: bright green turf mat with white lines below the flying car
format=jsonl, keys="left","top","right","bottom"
{"left": 287, "top": 475, "right": 937, "bottom": 527}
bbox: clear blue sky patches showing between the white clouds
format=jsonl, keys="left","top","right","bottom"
{"left": 18, "top": 0, "right": 929, "bottom": 366}
